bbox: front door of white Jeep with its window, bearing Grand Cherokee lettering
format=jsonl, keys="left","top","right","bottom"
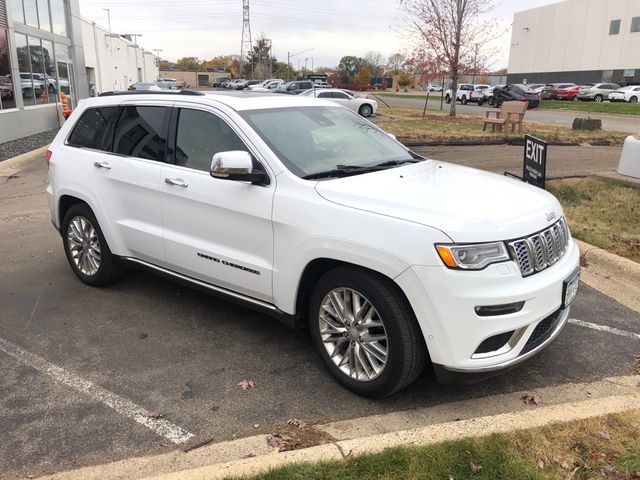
{"left": 161, "top": 108, "right": 275, "bottom": 302}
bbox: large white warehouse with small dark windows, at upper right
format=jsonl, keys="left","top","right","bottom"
{"left": 507, "top": 0, "right": 640, "bottom": 84}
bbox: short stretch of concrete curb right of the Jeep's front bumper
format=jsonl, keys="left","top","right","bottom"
{"left": 575, "top": 240, "right": 640, "bottom": 313}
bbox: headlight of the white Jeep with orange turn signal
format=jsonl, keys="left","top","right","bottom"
{"left": 436, "top": 242, "right": 511, "bottom": 270}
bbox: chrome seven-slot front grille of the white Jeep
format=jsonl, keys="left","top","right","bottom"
{"left": 509, "top": 218, "right": 569, "bottom": 277}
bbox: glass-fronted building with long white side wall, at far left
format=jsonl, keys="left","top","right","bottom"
{"left": 0, "top": 0, "right": 158, "bottom": 143}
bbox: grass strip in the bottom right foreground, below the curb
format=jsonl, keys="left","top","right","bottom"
{"left": 230, "top": 410, "right": 640, "bottom": 480}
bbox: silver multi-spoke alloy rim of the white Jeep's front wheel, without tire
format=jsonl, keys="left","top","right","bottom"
{"left": 318, "top": 288, "right": 389, "bottom": 382}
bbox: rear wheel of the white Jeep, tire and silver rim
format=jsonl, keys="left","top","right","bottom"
{"left": 61, "top": 203, "right": 122, "bottom": 286}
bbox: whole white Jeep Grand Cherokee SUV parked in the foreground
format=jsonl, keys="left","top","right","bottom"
{"left": 47, "top": 92, "right": 579, "bottom": 396}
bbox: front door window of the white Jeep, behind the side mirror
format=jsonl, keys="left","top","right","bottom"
{"left": 176, "top": 108, "right": 247, "bottom": 172}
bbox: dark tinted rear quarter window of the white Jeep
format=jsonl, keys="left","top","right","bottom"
{"left": 68, "top": 107, "right": 119, "bottom": 152}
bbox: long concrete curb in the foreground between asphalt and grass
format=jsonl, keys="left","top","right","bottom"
{"left": 41, "top": 375, "right": 640, "bottom": 480}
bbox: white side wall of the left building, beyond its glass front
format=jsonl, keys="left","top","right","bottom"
{"left": 82, "top": 19, "right": 159, "bottom": 94}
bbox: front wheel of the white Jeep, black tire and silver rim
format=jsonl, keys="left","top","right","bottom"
{"left": 309, "top": 267, "right": 427, "bottom": 397}
